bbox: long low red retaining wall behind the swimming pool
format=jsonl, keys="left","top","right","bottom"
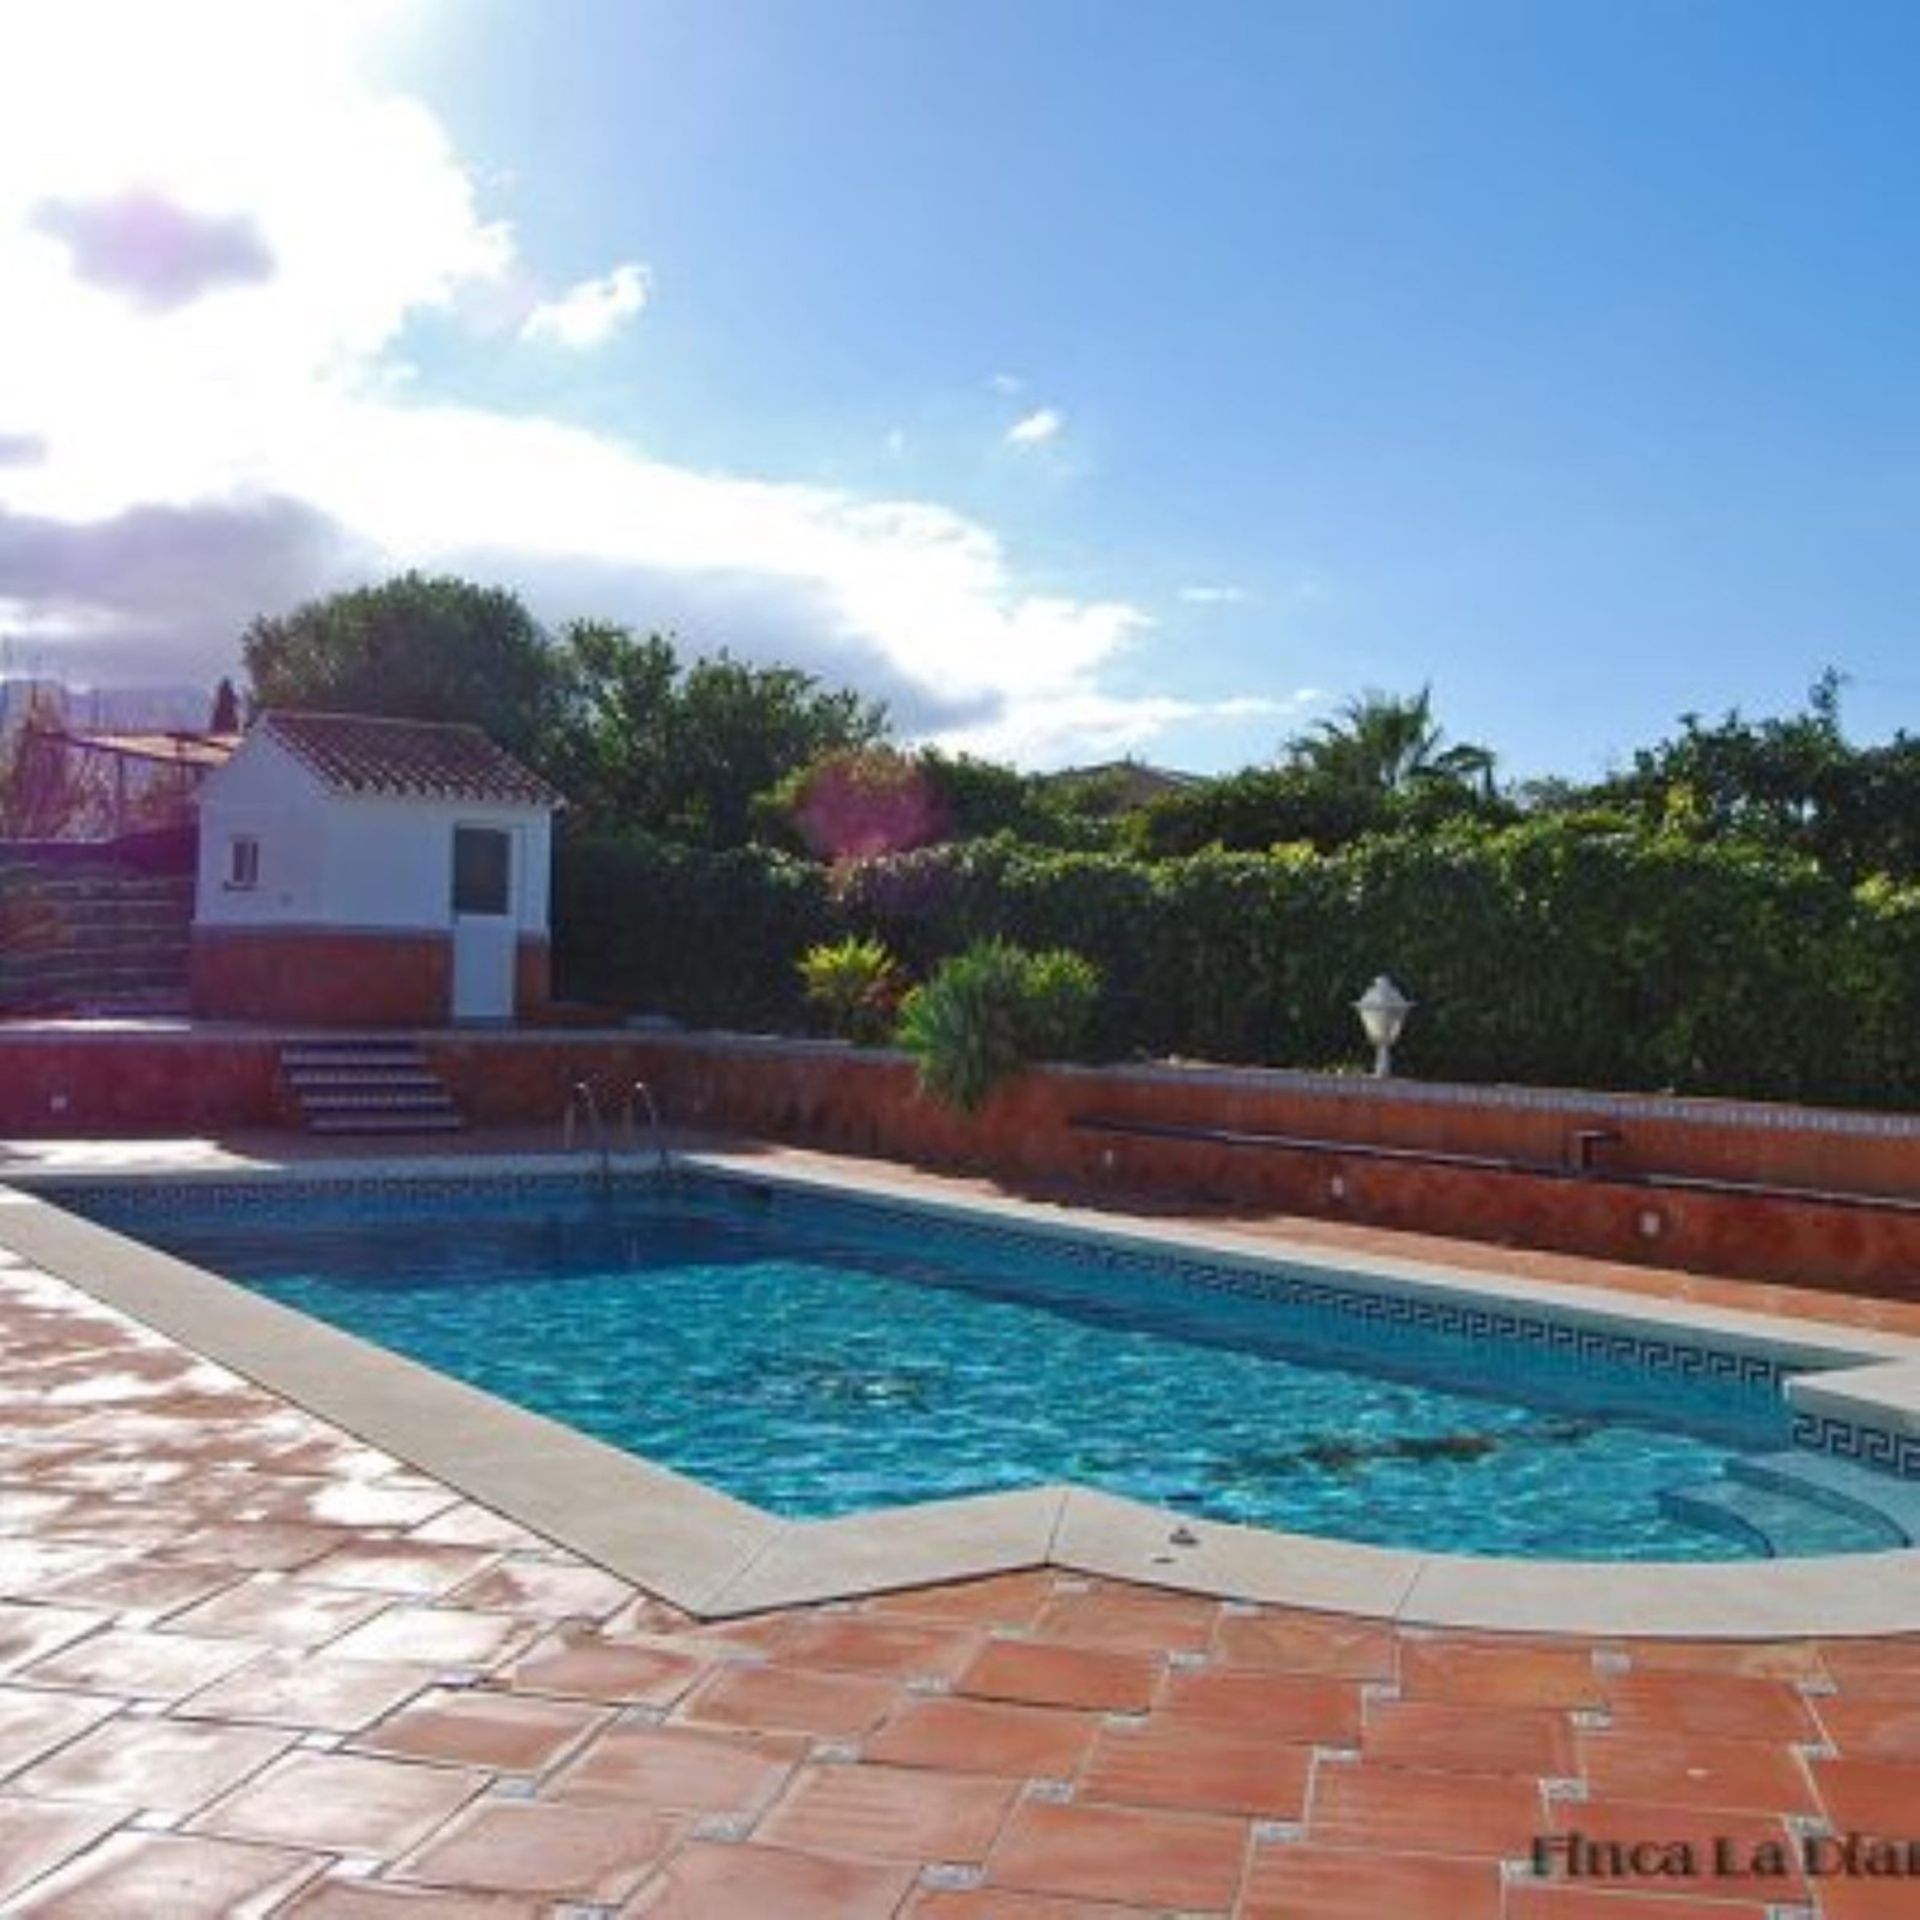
{"left": 0, "top": 1027, "right": 1920, "bottom": 1298}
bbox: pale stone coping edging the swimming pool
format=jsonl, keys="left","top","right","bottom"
{"left": 0, "top": 1152, "right": 1920, "bottom": 1640}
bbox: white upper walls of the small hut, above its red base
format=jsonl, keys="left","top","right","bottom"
{"left": 194, "top": 735, "right": 553, "bottom": 933}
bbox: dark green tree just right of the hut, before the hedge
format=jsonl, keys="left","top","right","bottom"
{"left": 553, "top": 622, "right": 887, "bottom": 847}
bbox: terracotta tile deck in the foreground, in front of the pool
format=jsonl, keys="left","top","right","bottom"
{"left": 0, "top": 1136, "right": 1920, "bottom": 1920}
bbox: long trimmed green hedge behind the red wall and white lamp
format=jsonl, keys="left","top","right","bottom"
{"left": 557, "top": 820, "right": 1920, "bottom": 1106}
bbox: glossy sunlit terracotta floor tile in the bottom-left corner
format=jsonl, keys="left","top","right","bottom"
{"left": 8, "top": 1834, "right": 328, "bottom": 1920}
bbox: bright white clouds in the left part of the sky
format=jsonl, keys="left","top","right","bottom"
{"left": 0, "top": 0, "right": 1182, "bottom": 756}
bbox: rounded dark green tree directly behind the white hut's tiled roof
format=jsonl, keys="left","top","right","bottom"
{"left": 242, "top": 574, "right": 566, "bottom": 762}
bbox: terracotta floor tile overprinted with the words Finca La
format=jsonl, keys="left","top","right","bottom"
{"left": 1536, "top": 1799, "right": 1807, "bottom": 1901}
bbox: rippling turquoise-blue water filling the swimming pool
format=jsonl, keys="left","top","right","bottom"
{"left": 71, "top": 1181, "right": 1887, "bottom": 1559}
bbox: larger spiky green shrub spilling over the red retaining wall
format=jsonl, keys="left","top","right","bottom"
{"left": 899, "top": 941, "right": 1100, "bottom": 1114}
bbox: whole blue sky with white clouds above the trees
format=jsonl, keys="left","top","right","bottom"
{"left": 0, "top": 0, "right": 1920, "bottom": 774}
